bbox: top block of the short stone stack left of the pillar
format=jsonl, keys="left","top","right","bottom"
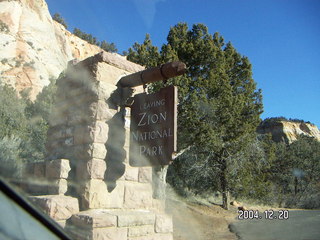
{"left": 46, "top": 159, "right": 71, "bottom": 179}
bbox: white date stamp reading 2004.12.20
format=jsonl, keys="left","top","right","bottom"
{"left": 238, "top": 209, "right": 289, "bottom": 220}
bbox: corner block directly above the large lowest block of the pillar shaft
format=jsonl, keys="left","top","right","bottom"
{"left": 77, "top": 158, "right": 107, "bottom": 179}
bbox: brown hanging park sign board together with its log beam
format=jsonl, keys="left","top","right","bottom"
{"left": 118, "top": 61, "right": 187, "bottom": 167}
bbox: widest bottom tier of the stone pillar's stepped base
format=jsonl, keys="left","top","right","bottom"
{"left": 66, "top": 209, "right": 173, "bottom": 240}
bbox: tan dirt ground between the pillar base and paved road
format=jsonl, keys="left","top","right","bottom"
{"left": 167, "top": 200, "right": 237, "bottom": 240}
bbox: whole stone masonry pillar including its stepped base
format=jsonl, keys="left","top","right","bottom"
{"left": 47, "top": 52, "right": 173, "bottom": 240}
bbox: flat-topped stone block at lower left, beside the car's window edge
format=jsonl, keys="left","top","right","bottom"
{"left": 29, "top": 195, "right": 79, "bottom": 220}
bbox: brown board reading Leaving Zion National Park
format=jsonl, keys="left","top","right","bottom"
{"left": 129, "top": 86, "right": 178, "bottom": 167}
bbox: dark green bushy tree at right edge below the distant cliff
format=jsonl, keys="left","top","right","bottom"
{"left": 271, "top": 135, "right": 320, "bottom": 208}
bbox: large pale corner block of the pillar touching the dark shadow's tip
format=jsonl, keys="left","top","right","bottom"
{"left": 80, "top": 179, "right": 124, "bottom": 209}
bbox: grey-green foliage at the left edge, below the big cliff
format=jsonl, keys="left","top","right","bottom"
{"left": 0, "top": 80, "right": 56, "bottom": 180}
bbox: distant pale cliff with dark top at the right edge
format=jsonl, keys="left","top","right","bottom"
{"left": 257, "top": 118, "right": 320, "bottom": 143}
